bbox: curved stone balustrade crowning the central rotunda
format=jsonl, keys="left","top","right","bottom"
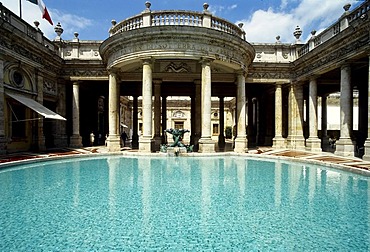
{"left": 109, "top": 4, "right": 245, "bottom": 39}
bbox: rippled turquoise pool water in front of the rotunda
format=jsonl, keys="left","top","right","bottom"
{"left": 0, "top": 157, "right": 370, "bottom": 251}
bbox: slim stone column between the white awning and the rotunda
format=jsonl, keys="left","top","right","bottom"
{"left": 69, "top": 81, "right": 82, "bottom": 148}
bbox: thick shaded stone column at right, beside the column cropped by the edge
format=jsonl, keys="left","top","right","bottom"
{"left": 334, "top": 65, "right": 355, "bottom": 157}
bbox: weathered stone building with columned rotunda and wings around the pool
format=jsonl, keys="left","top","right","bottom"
{"left": 0, "top": 2, "right": 370, "bottom": 159}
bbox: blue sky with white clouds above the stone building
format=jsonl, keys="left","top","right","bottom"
{"left": 0, "top": 0, "right": 364, "bottom": 43}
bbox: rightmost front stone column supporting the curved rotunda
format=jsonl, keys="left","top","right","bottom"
{"left": 234, "top": 72, "right": 248, "bottom": 153}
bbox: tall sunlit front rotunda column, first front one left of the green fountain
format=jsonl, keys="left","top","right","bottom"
{"left": 139, "top": 59, "right": 153, "bottom": 152}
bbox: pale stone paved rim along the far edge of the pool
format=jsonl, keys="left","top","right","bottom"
{"left": 0, "top": 146, "right": 370, "bottom": 177}
